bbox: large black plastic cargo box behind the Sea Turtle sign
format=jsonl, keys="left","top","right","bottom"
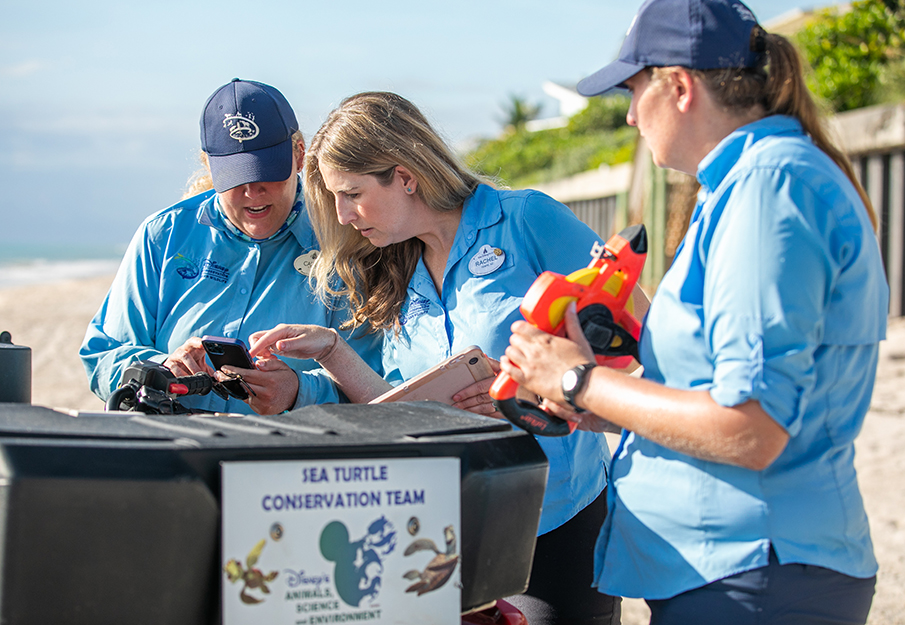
{"left": 0, "top": 402, "right": 547, "bottom": 625}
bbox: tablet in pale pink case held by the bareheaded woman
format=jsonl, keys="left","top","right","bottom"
{"left": 368, "top": 345, "right": 496, "bottom": 405}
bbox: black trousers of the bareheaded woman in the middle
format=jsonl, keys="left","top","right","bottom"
{"left": 506, "top": 490, "right": 622, "bottom": 625}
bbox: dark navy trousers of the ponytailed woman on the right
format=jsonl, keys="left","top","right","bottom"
{"left": 647, "top": 549, "right": 877, "bottom": 625}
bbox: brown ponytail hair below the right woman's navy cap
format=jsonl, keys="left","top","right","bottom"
{"left": 654, "top": 26, "right": 878, "bottom": 231}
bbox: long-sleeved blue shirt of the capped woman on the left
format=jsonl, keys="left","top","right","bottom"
{"left": 79, "top": 179, "right": 380, "bottom": 414}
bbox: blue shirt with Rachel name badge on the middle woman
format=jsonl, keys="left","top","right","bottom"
{"left": 383, "top": 185, "right": 609, "bottom": 534}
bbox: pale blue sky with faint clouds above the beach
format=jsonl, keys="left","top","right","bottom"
{"left": 0, "top": 0, "right": 831, "bottom": 260}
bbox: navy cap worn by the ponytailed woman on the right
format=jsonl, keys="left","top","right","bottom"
{"left": 578, "top": 0, "right": 761, "bottom": 96}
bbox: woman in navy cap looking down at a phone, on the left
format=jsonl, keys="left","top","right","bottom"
{"left": 79, "top": 79, "right": 380, "bottom": 414}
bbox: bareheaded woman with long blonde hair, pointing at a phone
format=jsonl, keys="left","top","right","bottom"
{"left": 252, "top": 93, "right": 620, "bottom": 624}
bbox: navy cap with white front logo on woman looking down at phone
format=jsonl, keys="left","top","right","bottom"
{"left": 201, "top": 78, "right": 299, "bottom": 193}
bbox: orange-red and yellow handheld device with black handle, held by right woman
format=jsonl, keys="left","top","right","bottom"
{"left": 490, "top": 224, "right": 647, "bottom": 436}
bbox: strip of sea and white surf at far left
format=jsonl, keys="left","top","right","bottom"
{"left": 0, "top": 241, "right": 126, "bottom": 289}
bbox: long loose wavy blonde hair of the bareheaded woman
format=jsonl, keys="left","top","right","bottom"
{"left": 305, "top": 92, "right": 482, "bottom": 332}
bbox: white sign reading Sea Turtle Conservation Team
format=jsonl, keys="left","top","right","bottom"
{"left": 221, "top": 458, "right": 462, "bottom": 625}
